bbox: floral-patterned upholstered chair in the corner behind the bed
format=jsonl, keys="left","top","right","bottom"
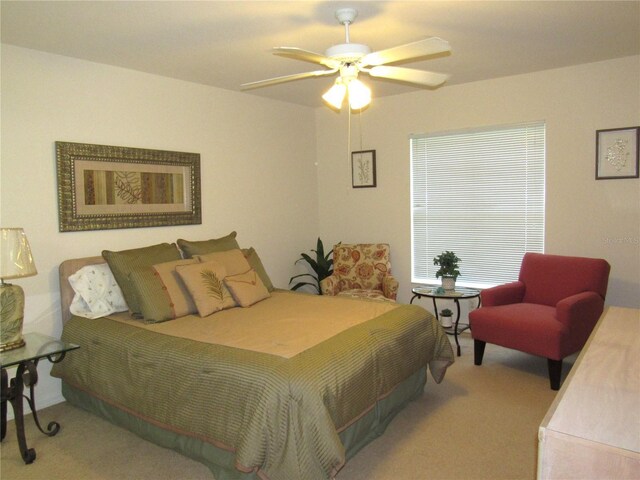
{"left": 320, "top": 243, "right": 398, "bottom": 301}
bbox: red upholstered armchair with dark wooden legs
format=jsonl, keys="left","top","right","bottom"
{"left": 469, "top": 253, "right": 610, "bottom": 390}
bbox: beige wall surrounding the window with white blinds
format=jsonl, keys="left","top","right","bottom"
{"left": 316, "top": 57, "right": 640, "bottom": 308}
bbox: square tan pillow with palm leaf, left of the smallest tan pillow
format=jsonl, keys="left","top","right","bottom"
{"left": 177, "top": 261, "right": 236, "bottom": 317}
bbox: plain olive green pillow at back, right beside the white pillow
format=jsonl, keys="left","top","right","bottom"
{"left": 102, "top": 243, "right": 182, "bottom": 317}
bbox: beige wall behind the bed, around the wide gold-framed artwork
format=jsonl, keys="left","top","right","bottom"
{"left": 0, "top": 45, "right": 318, "bottom": 406}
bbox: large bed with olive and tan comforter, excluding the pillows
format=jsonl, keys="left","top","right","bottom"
{"left": 52, "top": 249, "right": 454, "bottom": 480}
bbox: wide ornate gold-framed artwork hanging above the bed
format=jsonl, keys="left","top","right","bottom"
{"left": 55, "top": 142, "right": 202, "bottom": 232}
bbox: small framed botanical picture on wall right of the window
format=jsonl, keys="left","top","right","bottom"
{"left": 596, "top": 127, "right": 640, "bottom": 180}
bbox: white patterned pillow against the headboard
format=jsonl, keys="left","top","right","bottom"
{"left": 69, "top": 263, "right": 128, "bottom": 318}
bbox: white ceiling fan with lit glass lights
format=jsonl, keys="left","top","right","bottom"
{"left": 241, "top": 8, "right": 451, "bottom": 110}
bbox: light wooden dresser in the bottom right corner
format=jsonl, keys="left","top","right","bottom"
{"left": 538, "top": 307, "right": 640, "bottom": 480}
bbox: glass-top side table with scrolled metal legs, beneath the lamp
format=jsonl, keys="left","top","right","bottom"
{"left": 0, "top": 333, "right": 80, "bottom": 464}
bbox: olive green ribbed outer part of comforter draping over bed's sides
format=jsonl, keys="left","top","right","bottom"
{"left": 52, "top": 294, "right": 454, "bottom": 480}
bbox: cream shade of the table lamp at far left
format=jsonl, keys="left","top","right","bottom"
{"left": 0, "top": 228, "right": 38, "bottom": 280}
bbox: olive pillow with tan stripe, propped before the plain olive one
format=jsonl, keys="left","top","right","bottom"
{"left": 129, "top": 258, "right": 197, "bottom": 323}
